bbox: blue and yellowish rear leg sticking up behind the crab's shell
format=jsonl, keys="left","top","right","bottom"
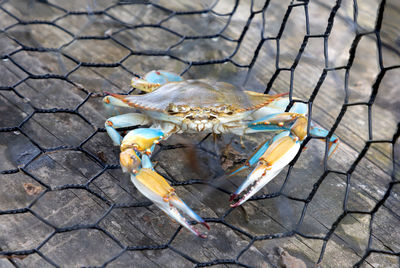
{"left": 131, "top": 71, "right": 183, "bottom": 93}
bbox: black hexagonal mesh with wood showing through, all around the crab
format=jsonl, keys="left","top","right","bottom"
{"left": 0, "top": 0, "right": 400, "bottom": 267}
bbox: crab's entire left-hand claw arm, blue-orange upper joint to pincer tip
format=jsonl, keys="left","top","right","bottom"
{"left": 120, "top": 128, "right": 210, "bottom": 238}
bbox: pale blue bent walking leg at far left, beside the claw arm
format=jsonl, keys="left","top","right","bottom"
{"left": 104, "top": 113, "right": 148, "bottom": 146}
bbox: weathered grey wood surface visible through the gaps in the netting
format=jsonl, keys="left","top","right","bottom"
{"left": 0, "top": 1, "right": 400, "bottom": 267}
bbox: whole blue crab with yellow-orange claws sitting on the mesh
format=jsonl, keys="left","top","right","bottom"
{"left": 103, "top": 70, "right": 338, "bottom": 238}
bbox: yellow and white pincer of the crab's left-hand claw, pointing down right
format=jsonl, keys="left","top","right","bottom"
{"left": 131, "top": 168, "right": 210, "bottom": 238}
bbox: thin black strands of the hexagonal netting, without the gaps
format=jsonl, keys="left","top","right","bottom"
{"left": 0, "top": 0, "right": 400, "bottom": 267}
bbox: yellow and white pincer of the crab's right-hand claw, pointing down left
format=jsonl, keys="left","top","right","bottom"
{"left": 229, "top": 131, "right": 300, "bottom": 207}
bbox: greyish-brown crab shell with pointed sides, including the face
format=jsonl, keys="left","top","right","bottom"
{"left": 108, "top": 80, "right": 285, "bottom": 133}
